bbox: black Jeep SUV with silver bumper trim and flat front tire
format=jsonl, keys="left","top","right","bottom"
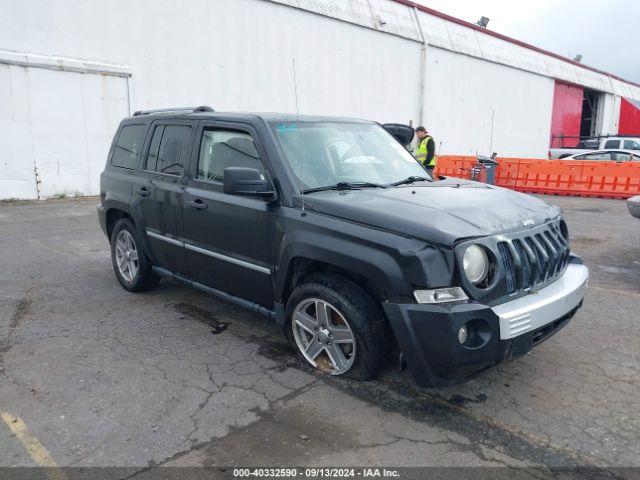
{"left": 98, "top": 107, "right": 588, "bottom": 386}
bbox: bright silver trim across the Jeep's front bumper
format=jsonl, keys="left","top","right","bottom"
{"left": 492, "top": 263, "right": 589, "bottom": 340}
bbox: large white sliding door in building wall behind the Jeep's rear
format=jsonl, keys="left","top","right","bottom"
{"left": 0, "top": 57, "right": 129, "bottom": 199}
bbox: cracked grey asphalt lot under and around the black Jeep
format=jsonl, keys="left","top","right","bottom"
{"left": 0, "top": 197, "right": 640, "bottom": 478}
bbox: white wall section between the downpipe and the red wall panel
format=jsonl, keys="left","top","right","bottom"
{"left": 425, "top": 47, "right": 554, "bottom": 158}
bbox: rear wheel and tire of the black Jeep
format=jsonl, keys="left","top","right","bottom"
{"left": 111, "top": 218, "right": 160, "bottom": 292}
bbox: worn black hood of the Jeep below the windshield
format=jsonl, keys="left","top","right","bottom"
{"left": 304, "top": 179, "right": 560, "bottom": 245}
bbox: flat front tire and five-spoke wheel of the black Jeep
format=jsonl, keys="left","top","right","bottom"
{"left": 285, "top": 274, "right": 388, "bottom": 380}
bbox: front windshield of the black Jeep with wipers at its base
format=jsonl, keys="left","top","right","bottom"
{"left": 271, "top": 121, "right": 429, "bottom": 190}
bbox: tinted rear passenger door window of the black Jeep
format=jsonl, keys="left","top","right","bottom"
{"left": 144, "top": 125, "right": 191, "bottom": 176}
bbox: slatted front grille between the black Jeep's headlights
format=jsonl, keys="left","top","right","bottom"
{"left": 498, "top": 226, "right": 570, "bottom": 294}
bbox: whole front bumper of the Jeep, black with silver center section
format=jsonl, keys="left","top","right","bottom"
{"left": 383, "top": 257, "right": 589, "bottom": 387}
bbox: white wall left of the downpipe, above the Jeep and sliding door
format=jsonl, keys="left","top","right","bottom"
{"left": 0, "top": 0, "right": 420, "bottom": 122}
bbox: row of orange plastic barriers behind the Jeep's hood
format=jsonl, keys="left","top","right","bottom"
{"left": 436, "top": 155, "right": 640, "bottom": 198}
